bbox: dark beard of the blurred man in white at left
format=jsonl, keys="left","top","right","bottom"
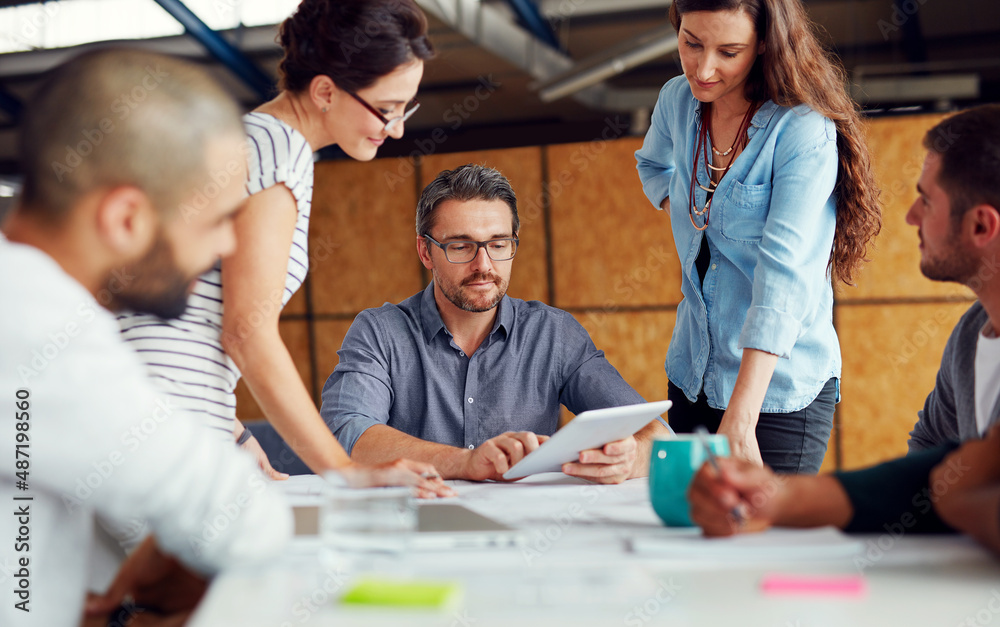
{"left": 107, "top": 232, "right": 195, "bottom": 320}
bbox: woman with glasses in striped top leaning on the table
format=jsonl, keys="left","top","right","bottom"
{"left": 114, "top": 0, "right": 447, "bottom": 495}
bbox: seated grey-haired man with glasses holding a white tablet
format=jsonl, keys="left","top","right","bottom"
{"left": 321, "top": 165, "right": 669, "bottom": 483}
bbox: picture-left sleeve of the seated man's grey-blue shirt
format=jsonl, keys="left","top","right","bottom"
{"left": 320, "top": 311, "right": 392, "bottom": 455}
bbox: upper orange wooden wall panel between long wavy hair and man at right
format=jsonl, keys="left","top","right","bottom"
{"left": 837, "top": 115, "right": 971, "bottom": 301}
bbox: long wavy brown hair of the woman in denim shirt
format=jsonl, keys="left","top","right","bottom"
{"left": 669, "top": 0, "right": 882, "bottom": 285}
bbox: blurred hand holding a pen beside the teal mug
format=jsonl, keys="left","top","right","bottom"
{"left": 688, "top": 458, "right": 787, "bottom": 536}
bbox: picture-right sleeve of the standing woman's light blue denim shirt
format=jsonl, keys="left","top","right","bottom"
{"left": 738, "top": 113, "right": 838, "bottom": 359}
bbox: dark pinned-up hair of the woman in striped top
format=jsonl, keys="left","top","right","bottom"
{"left": 278, "top": 0, "right": 434, "bottom": 92}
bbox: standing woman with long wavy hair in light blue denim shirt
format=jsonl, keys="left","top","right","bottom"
{"left": 636, "top": 0, "right": 881, "bottom": 473}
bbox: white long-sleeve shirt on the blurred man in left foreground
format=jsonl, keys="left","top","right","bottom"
{"left": 0, "top": 237, "right": 292, "bottom": 627}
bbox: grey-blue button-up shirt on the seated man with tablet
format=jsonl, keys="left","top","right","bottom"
{"left": 321, "top": 283, "right": 643, "bottom": 453}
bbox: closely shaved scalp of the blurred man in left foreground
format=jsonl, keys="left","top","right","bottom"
{"left": 20, "top": 50, "right": 243, "bottom": 222}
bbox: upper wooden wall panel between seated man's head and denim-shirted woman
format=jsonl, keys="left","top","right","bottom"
{"left": 548, "top": 138, "right": 681, "bottom": 309}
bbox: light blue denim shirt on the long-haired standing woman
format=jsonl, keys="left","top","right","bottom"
{"left": 635, "top": 76, "right": 841, "bottom": 413}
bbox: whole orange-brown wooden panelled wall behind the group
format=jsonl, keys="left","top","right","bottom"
{"left": 250, "top": 115, "right": 971, "bottom": 470}
